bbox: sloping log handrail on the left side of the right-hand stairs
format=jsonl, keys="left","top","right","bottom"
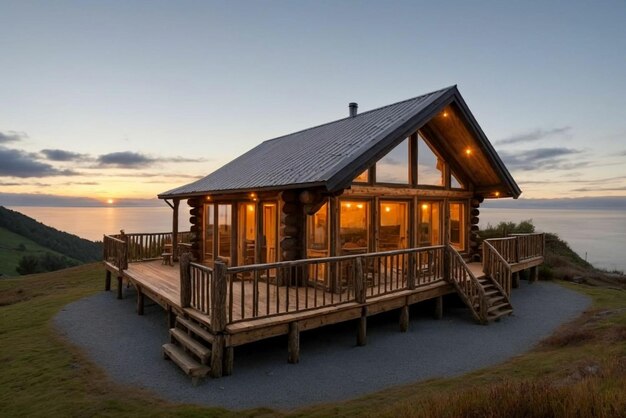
{"left": 447, "top": 246, "right": 487, "bottom": 324}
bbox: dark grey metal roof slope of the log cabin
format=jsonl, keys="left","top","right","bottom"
{"left": 159, "top": 86, "right": 510, "bottom": 198}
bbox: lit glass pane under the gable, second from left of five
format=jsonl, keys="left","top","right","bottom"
{"left": 339, "top": 200, "right": 369, "bottom": 254}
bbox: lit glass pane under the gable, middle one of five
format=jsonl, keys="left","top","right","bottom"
{"left": 378, "top": 202, "right": 409, "bottom": 251}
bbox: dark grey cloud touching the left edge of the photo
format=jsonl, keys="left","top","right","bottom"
{"left": 0, "top": 147, "right": 77, "bottom": 178}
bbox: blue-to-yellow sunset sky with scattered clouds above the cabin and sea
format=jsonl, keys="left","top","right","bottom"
{"left": 0, "top": 0, "right": 626, "bottom": 204}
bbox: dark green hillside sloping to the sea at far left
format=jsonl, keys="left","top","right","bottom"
{"left": 0, "top": 206, "right": 102, "bottom": 276}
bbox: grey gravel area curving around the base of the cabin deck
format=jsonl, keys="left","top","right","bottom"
{"left": 54, "top": 281, "right": 591, "bottom": 409}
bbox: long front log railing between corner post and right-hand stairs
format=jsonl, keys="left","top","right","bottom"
{"left": 219, "top": 246, "right": 445, "bottom": 323}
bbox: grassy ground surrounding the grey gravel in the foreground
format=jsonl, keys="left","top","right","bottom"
{"left": 0, "top": 264, "right": 626, "bottom": 417}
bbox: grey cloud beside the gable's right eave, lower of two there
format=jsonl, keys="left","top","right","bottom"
{"left": 499, "top": 147, "right": 589, "bottom": 170}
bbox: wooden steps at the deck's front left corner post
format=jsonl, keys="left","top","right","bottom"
{"left": 162, "top": 316, "right": 214, "bottom": 385}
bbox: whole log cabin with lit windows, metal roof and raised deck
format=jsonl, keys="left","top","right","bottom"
{"left": 105, "top": 86, "right": 544, "bottom": 380}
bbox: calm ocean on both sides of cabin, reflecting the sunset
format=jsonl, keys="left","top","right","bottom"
{"left": 9, "top": 205, "right": 626, "bottom": 271}
